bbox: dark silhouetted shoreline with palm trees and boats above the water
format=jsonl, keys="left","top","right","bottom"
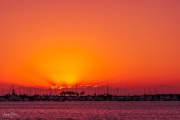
{"left": 0, "top": 90, "right": 180, "bottom": 102}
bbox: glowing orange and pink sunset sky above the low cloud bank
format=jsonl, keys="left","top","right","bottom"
{"left": 0, "top": 0, "right": 180, "bottom": 90}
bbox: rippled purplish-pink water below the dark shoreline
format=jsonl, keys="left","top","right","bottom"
{"left": 0, "top": 101, "right": 180, "bottom": 120}
